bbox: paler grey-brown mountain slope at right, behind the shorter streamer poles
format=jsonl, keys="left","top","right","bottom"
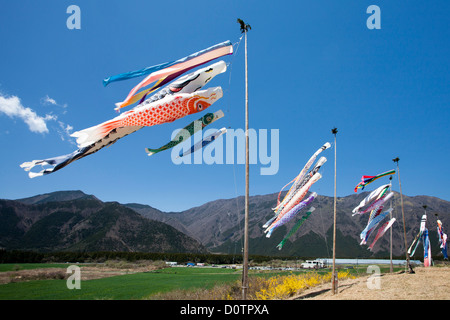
{"left": 126, "top": 192, "right": 450, "bottom": 258}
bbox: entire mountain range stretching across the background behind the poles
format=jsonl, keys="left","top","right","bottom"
{"left": 0, "top": 191, "right": 450, "bottom": 258}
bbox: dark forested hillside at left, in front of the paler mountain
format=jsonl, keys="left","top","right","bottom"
{"left": 0, "top": 191, "right": 206, "bottom": 253}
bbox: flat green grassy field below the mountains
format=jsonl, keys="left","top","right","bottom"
{"left": 0, "top": 264, "right": 400, "bottom": 300}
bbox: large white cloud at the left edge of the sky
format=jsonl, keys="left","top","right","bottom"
{"left": 0, "top": 95, "right": 53, "bottom": 133}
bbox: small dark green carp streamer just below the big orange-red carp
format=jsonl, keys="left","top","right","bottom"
{"left": 145, "top": 110, "right": 224, "bottom": 156}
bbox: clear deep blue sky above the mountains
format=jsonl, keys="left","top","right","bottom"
{"left": 0, "top": 0, "right": 450, "bottom": 211}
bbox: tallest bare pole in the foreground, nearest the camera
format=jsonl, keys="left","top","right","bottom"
{"left": 237, "top": 18, "right": 251, "bottom": 300}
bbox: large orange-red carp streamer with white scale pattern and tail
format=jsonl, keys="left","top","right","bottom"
{"left": 71, "top": 87, "right": 223, "bottom": 148}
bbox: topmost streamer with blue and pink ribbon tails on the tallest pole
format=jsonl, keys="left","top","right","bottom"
{"left": 103, "top": 41, "right": 233, "bottom": 110}
